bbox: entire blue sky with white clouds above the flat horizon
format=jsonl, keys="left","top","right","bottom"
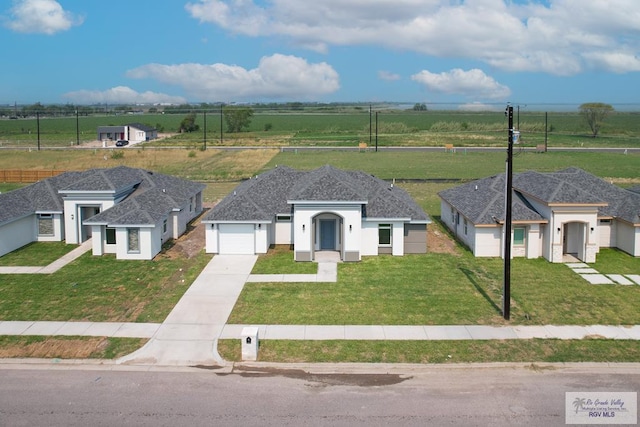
{"left": 0, "top": 0, "right": 640, "bottom": 110}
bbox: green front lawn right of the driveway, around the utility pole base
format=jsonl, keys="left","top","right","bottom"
{"left": 229, "top": 250, "right": 640, "bottom": 325}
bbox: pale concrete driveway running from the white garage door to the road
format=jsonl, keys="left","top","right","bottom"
{"left": 117, "top": 255, "right": 258, "bottom": 366}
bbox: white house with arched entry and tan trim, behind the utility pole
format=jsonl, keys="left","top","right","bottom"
{"left": 439, "top": 168, "right": 640, "bottom": 263}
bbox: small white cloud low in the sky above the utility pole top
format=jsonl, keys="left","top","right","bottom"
{"left": 411, "top": 68, "right": 511, "bottom": 99}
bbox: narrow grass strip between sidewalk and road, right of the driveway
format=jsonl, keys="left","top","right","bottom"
{"left": 218, "top": 339, "right": 640, "bottom": 363}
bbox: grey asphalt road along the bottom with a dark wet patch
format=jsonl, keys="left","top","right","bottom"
{"left": 0, "top": 364, "right": 640, "bottom": 426}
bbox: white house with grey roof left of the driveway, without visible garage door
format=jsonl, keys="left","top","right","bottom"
{"left": 0, "top": 166, "right": 205, "bottom": 259}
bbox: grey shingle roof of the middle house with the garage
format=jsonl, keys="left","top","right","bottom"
{"left": 204, "top": 165, "right": 430, "bottom": 222}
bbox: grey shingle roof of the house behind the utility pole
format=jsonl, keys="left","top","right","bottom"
{"left": 438, "top": 167, "right": 640, "bottom": 224}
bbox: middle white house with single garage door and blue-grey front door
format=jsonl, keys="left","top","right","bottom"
{"left": 202, "top": 166, "right": 431, "bottom": 261}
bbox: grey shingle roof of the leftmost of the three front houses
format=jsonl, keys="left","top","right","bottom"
{"left": 0, "top": 166, "right": 205, "bottom": 224}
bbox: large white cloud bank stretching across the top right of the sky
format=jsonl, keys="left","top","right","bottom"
{"left": 186, "top": 0, "right": 640, "bottom": 75}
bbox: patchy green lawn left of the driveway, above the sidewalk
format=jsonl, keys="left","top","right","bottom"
{"left": 0, "top": 252, "right": 211, "bottom": 322}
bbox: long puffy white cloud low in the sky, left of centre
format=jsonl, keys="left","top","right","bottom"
{"left": 127, "top": 54, "right": 340, "bottom": 101}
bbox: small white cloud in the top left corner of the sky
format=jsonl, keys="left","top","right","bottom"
{"left": 5, "top": 0, "right": 83, "bottom": 35}
